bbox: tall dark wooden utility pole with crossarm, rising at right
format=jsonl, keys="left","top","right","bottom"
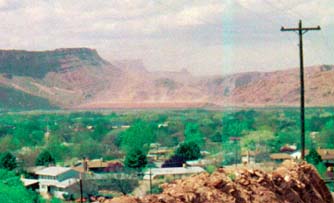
{"left": 281, "top": 20, "right": 320, "bottom": 160}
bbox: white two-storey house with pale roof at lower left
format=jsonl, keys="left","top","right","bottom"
{"left": 36, "top": 166, "right": 79, "bottom": 198}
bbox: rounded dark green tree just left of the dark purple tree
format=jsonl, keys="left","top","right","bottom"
{"left": 124, "top": 148, "right": 147, "bottom": 169}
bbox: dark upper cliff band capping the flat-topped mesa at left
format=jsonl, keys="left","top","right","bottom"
{"left": 0, "top": 48, "right": 107, "bottom": 78}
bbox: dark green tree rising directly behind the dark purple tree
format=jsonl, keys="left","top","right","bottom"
{"left": 175, "top": 142, "right": 201, "bottom": 161}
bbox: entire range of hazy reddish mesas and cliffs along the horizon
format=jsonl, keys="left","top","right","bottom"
{"left": 0, "top": 48, "right": 334, "bottom": 109}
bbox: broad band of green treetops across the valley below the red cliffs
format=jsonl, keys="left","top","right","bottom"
{"left": 0, "top": 108, "right": 334, "bottom": 167}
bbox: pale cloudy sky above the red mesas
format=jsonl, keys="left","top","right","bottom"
{"left": 0, "top": 0, "right": 334, "bottom": 74}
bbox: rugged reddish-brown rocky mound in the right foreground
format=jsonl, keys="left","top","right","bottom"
{"left": 105, "top": 161, "right": 334, "bottom": 203}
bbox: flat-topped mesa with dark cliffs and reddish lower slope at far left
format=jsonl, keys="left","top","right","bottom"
{"left": 0, "top": 48, "right": 120, "bottom": 108}
